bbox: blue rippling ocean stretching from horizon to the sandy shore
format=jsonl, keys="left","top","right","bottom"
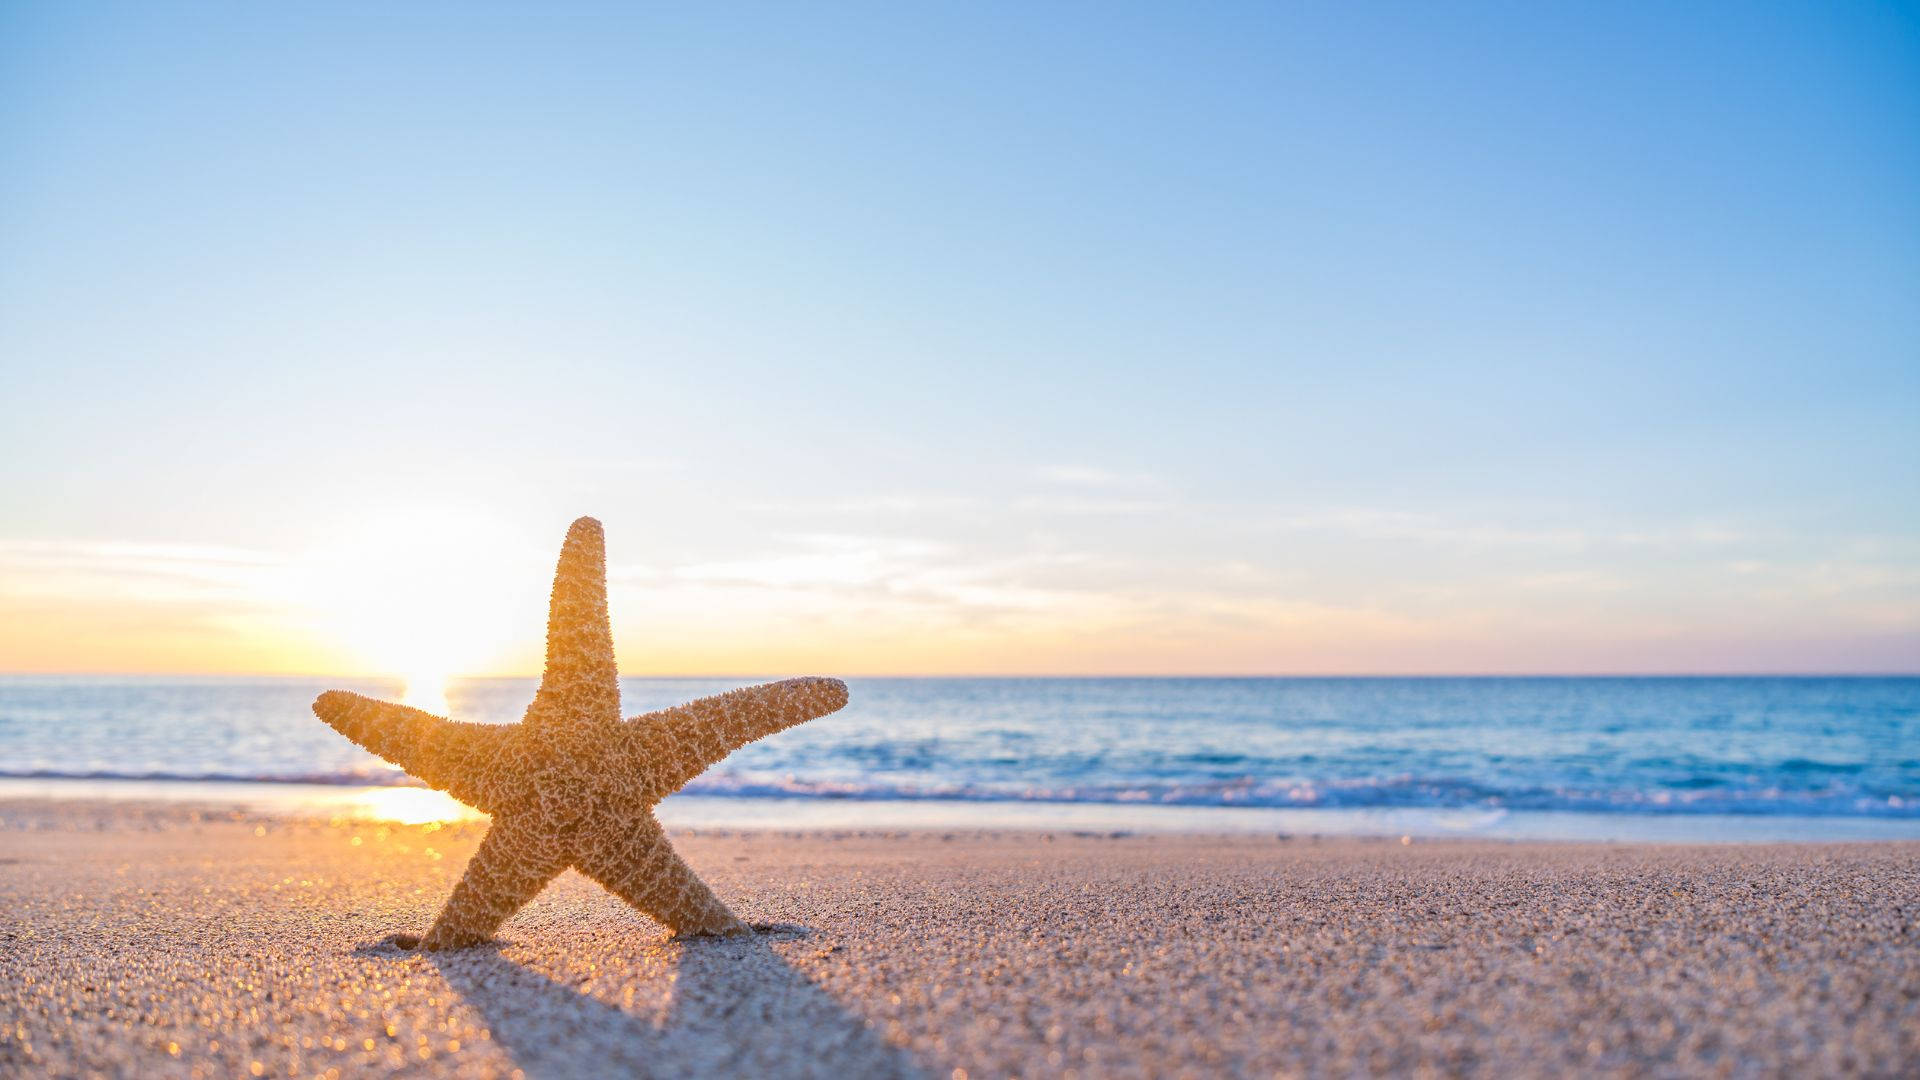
{"left": 0, "top": 676, "right": 1920, "bottom": 840}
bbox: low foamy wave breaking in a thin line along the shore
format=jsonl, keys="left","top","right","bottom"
{"left": 0, "top": 767, "right": 1920, "bottom": 819}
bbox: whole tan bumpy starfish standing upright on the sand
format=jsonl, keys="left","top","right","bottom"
{"left": 313, "top": 517, "right": 847, "bottom": 949}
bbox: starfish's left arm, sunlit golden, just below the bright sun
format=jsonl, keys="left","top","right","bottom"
{"left": 313, "top": 690, "right": 515, "bottom": 813}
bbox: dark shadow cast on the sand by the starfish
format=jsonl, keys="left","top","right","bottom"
{"left": 359, "top": 926, "right": 927, "bottom": 1080}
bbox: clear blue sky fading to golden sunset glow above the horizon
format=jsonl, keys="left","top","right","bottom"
{"left": 0, "top": 0, "right": 1920, "bottom": 676}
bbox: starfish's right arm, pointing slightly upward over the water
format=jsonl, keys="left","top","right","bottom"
{"left": 626, "top": 678, "right": 847, "bottom": 799}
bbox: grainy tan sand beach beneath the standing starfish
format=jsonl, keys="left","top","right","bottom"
{"left": 0, "top": 803, "right": 1920, "bottom": 1076}
